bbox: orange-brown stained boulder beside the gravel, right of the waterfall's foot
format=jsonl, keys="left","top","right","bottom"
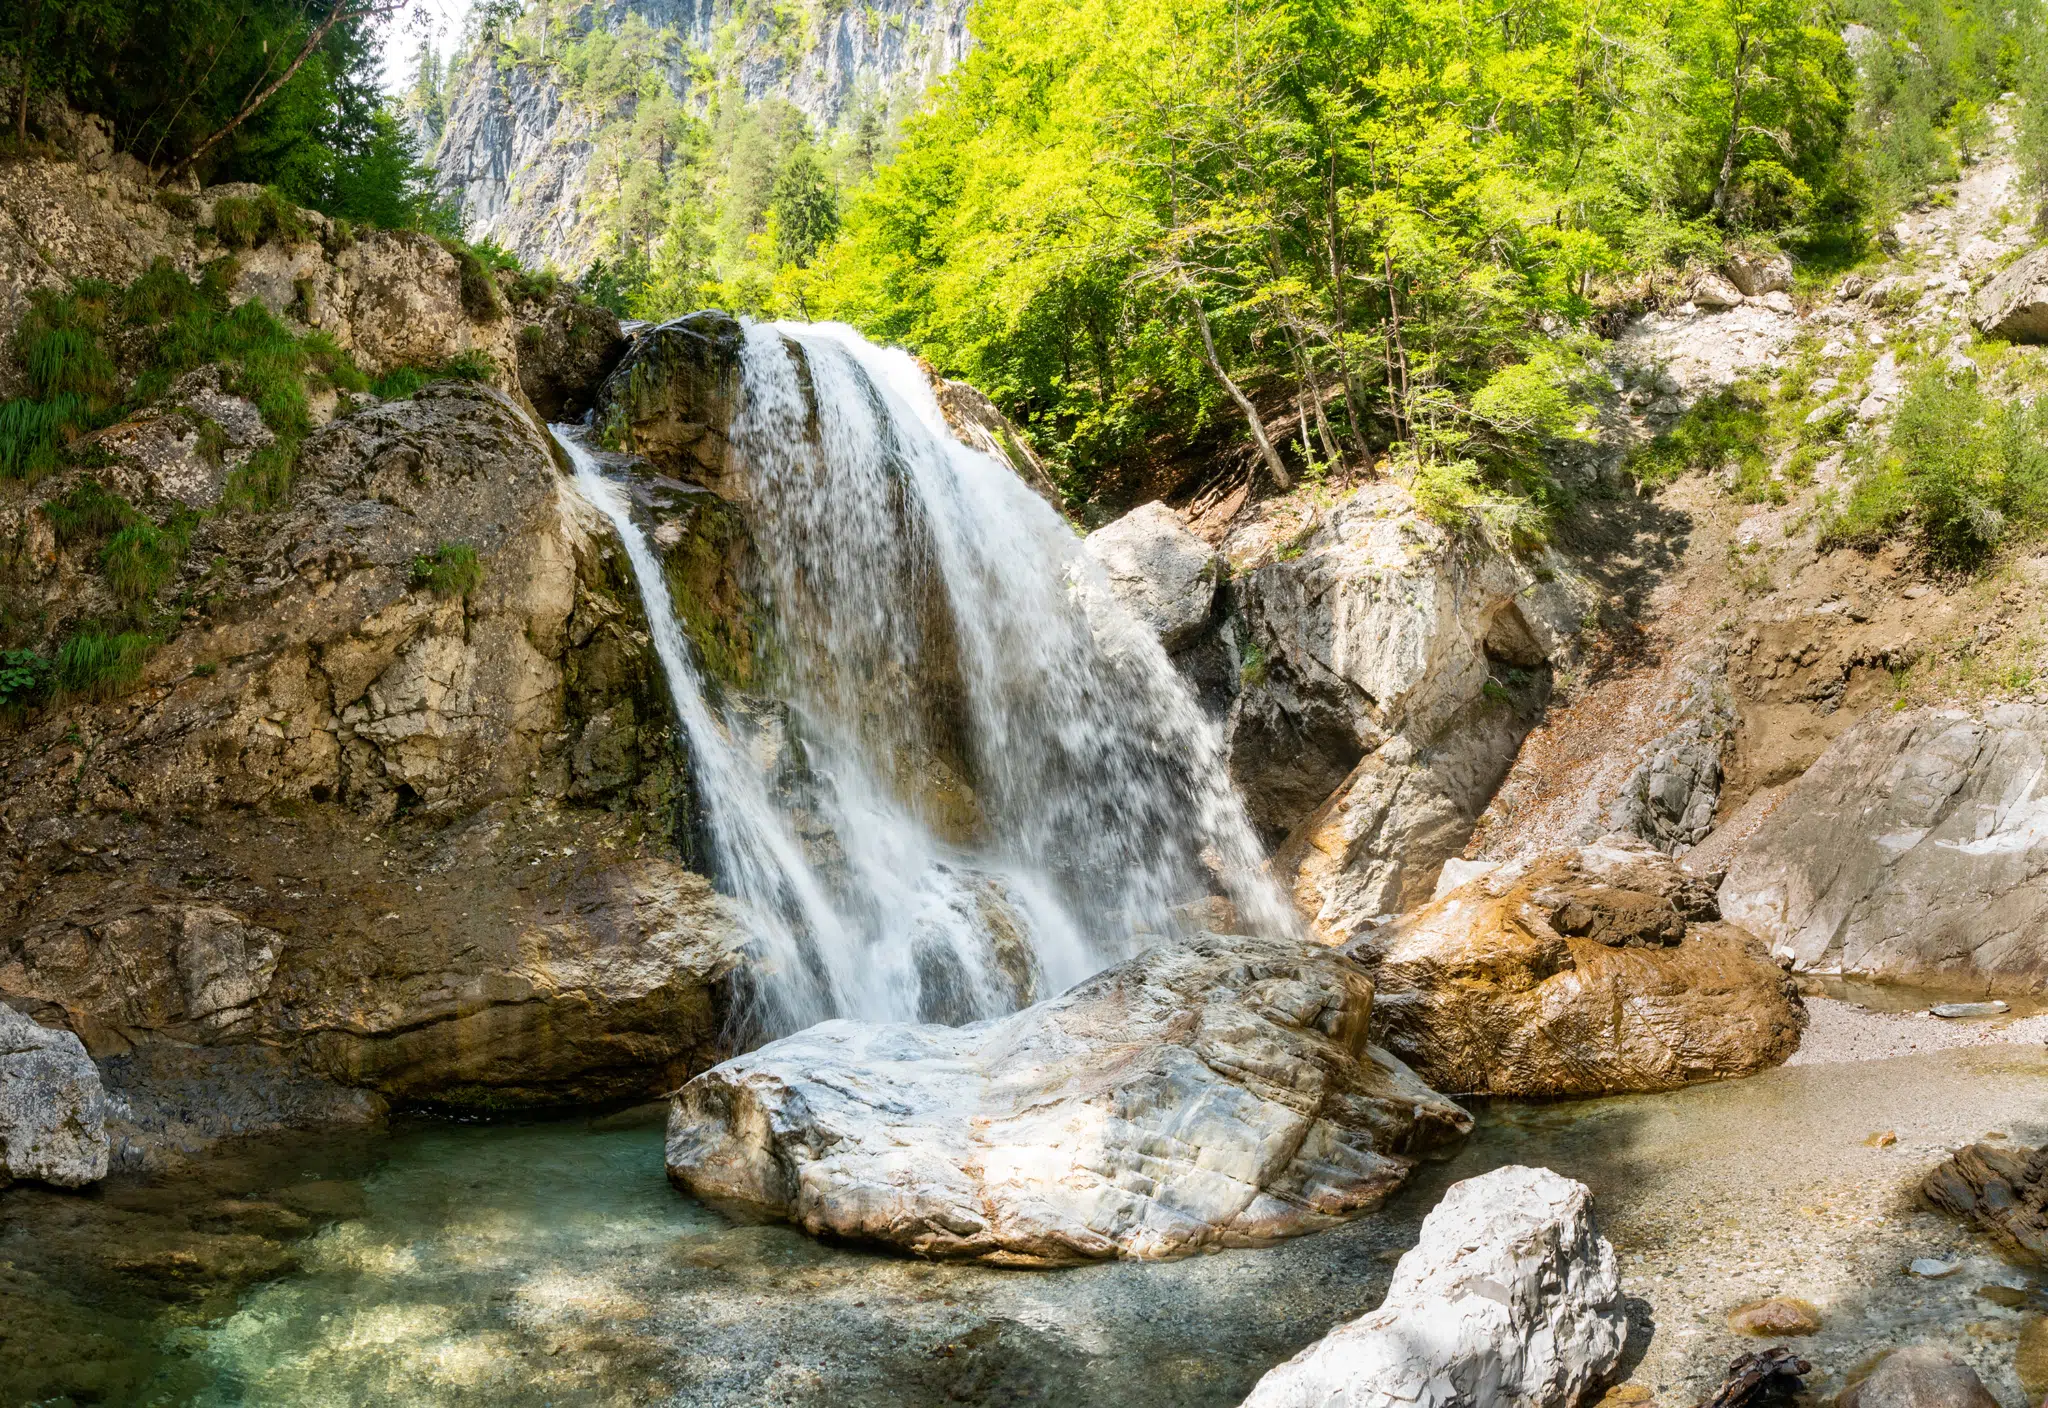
{"left": 1352, "top": 837, "right": 1806, "bottom": 1097}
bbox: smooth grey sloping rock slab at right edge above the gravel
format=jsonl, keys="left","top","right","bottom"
{"left": 1720, "top": 704, "right": 2048, "bottom": 993}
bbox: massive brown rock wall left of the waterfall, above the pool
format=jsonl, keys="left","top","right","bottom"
{"left": 0, "top": 383, "right": 739, "bottom": 1137}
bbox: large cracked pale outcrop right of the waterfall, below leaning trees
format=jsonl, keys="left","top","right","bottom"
{"left": 1229, "top": 483, "right": 1585, "bottom": 939}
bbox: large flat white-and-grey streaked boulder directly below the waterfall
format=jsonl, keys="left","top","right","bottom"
{"left": 668, "top": 935, "right": 1470, "bottom": 1265}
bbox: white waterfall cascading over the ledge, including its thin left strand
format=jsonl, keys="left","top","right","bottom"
{"left": 557, "top": 323, "right": 1294, "bottom": 1031}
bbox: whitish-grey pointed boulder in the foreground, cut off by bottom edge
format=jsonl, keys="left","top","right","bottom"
{"left": 1243, "top": 1167, "right": 1628, "bottom": 1408}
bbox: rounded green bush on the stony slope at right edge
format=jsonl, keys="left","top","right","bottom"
{"left": 1825, "top": 368, "right": 2048, "bottom": 571}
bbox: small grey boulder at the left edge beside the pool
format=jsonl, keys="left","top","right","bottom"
{"left": 0, "top": 1005, "right": 106, "bottom": 1187}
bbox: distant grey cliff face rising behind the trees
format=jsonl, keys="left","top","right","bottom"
{"left": 430, "top": 0, "right": 971, "bottom": 270}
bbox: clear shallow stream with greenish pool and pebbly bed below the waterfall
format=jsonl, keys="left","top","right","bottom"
{"left": 0, "top": 1046, "right": 2048, "bottom": 1408}
